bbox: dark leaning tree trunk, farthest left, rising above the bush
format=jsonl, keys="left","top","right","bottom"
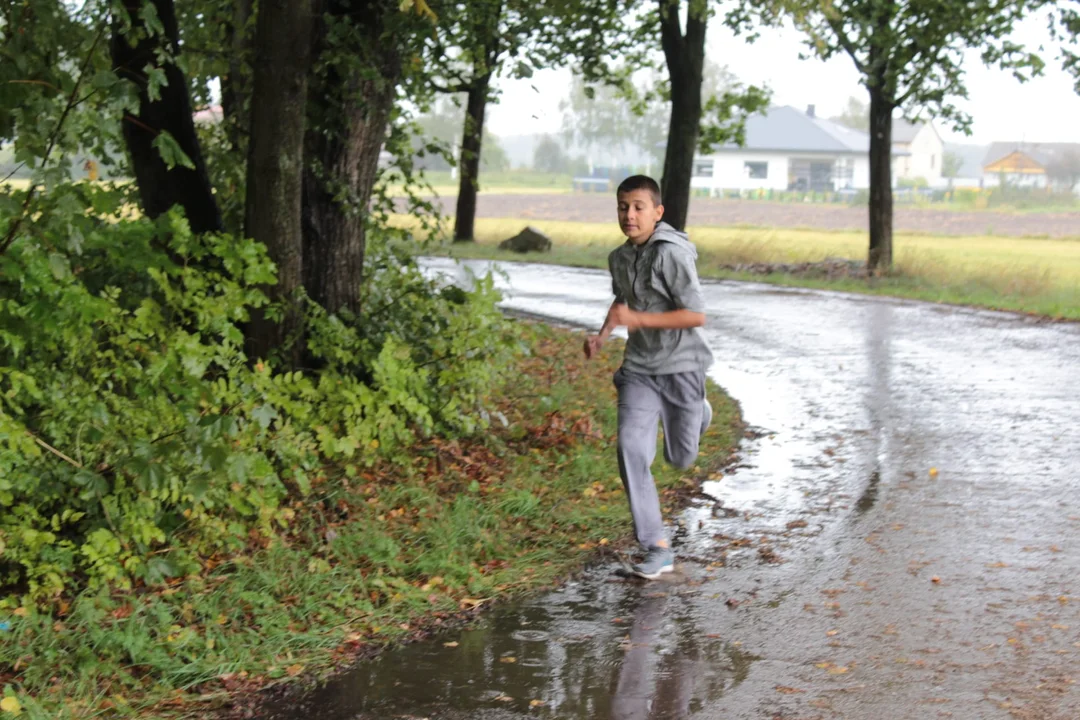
{"left": 110, "top": 0, "right": 221, "bottom": 232}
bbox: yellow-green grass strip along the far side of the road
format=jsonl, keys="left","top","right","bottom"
{"left": 395, "top": 217, "right": 1080, "bottom": 320}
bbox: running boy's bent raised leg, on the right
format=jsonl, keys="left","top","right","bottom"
{"left": 657, "top": 370, "right": 713, "bottom": 470}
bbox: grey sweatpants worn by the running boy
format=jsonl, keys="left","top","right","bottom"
{"left": 615, "top": 368, "right": 708, "bottom": 547}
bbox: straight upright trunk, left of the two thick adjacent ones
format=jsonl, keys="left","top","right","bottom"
{"left": 244, "top": 0, "right": 312, "bottom": 364}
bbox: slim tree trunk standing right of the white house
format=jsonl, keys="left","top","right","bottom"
{"left": 866, "top": 83, "right": 893, "bottom": 274}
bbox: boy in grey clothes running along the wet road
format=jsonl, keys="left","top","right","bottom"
{"left": 585, "top": 175, "right": 713, "bottom": 580}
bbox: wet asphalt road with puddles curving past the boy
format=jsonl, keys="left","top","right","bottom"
{"left": 265, "top": 260, "right": 1080, "bottom": 720}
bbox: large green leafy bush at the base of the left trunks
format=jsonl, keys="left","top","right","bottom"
{"left": 0, "top": 191, "right": 516, "bottom": 604}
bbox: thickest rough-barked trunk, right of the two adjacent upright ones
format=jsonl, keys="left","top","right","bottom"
{"left": 303, "top": 0, "right": 402, "bottom": 316}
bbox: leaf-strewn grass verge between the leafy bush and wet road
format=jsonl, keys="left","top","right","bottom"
{"left": 0, "top": 323, "right": 741, "bottom": 720}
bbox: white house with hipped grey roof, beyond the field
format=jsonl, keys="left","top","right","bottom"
{"left": 690, "top": 105, "right": 897, "bottom": 194}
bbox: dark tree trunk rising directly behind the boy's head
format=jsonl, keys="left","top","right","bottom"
{"left": 659, "top": 0, "right": 707, "bottom": 230}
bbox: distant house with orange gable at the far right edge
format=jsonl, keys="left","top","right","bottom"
{"left": 983, "top": 142, "right": 1080, "bottom": 192}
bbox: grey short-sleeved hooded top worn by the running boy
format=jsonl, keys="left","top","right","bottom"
{"left": 608, "top": 222, "right": 713, "bottom": 375}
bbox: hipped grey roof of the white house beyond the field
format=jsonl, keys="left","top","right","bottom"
{"left": 716, "top": 105, "right": 870, "bottom": 154}
